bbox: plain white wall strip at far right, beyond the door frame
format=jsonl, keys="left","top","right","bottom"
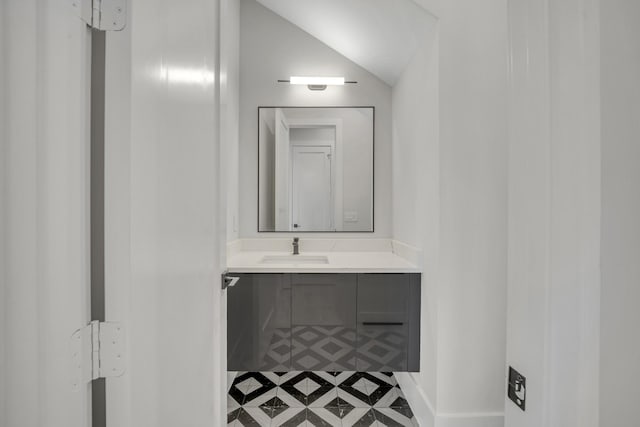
{"left": 600, "top": 0, "right": 640, "bottom": 427}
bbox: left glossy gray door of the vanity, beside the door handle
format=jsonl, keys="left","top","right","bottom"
{"left": 227, "top": 274, "right": 291, "bottom": 371}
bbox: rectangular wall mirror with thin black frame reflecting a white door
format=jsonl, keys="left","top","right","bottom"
{"left": 258, "top": 107, "right": 375, "bottom": 232}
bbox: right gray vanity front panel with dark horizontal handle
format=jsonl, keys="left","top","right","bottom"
{"left": 357, "top": 274, "right": 411, "bottom": 372}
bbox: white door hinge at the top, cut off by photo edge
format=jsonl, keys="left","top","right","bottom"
{"left": 71, "top": 0, "right": 127, "bottom": 31}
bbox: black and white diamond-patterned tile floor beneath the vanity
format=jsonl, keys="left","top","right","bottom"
{"left": 227, "top": 371, "right": 418, "bottom": 427}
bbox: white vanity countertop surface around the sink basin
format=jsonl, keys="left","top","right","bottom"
{"left": 227, "top": 251, "right": 421, "bottom": 273}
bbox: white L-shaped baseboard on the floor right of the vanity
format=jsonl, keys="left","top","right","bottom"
{"left": 395, "top": 372, "right": 504, "bottom": 427}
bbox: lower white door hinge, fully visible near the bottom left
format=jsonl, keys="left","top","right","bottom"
{"left": 70, "top": 320, "right": 125, "bottom": 390}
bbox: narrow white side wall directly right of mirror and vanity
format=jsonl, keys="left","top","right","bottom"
{"left": 392, "top": 18, "right": 440, "bottom": 405}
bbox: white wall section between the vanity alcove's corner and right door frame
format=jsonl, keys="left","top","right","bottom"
{"left": 438, "top": 0, "right": 507, "bottom": 425}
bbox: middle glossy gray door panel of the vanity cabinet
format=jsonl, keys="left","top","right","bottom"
{"left": 291, "top": 274, "right": 357, "bottom": 371}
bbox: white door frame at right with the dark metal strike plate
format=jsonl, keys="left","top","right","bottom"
{"left": 505, "top": 0, "right": 609, "bottom": 427}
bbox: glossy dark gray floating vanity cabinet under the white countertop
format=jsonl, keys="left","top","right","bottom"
{"left": 227, "top": 273, "right": 420, "bottom": 372}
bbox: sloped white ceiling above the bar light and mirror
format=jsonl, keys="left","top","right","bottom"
{"left": 257, "top": 0, "right": 435, "bottom": 86}
